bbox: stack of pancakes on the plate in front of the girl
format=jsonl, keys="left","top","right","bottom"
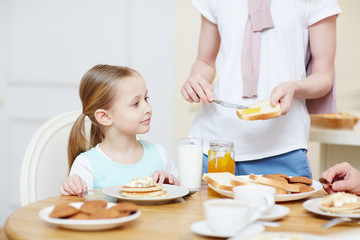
{"left": 120, "top": 177, "right": 167, "bottom": 198}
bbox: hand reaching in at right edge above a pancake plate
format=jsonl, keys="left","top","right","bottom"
{"left": 322, "top": 162, "right": 360, "bottom": 195}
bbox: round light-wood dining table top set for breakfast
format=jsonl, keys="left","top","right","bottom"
{"left": 5, "top": 183, "right": 359, "bottom": 240}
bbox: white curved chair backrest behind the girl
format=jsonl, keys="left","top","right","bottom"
{"left": 20, "top": 111, "right": 91, "bottom": 206}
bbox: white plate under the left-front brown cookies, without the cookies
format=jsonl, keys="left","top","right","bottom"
{"left": 39, "top": 202, "right": 141, "bottom": 231}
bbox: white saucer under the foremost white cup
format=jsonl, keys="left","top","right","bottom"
{"left": 190, "top": 221, "right": 265, "bottom": 238}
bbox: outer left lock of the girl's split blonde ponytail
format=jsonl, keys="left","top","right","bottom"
{"left": 68, "top": 113, "right": 90, "bottom": 172}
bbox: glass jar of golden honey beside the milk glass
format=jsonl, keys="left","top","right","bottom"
{"left": 208, "top": 141, "right": 235, "bottom": 174}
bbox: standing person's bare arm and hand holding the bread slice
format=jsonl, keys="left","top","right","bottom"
{"left": 271, "top": 15, "right": 337, "bottom": 115}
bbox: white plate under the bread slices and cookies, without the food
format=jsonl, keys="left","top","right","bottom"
{"left": 208, "top": 175, "right": 322, "bottom": 202}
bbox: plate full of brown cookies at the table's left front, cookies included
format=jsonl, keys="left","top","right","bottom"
{"left": 39, "top": 200, "right": 141, "bottom": 231}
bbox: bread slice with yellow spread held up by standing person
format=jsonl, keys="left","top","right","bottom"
{"left": 236, "top": 99, "right": 281, "bottom": 121}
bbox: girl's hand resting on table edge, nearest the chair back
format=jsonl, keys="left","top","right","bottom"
{"left": 59, "top": 174, "right": 88, "bottom": 197}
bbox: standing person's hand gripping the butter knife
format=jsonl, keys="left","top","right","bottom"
{"left": 181, "top": 74, "right": 214, "bottom": 105}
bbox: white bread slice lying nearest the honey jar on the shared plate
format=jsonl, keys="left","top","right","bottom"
{"left": 202, "top": 172, "right": 254, "bottom": 191}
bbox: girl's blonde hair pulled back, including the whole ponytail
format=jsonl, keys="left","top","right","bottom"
{"left": 68, "top": 65, "right": 139, "bottom": 169}
